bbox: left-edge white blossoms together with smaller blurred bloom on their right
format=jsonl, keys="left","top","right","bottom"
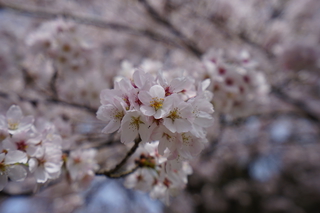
{"left": 0, "top": 105, "right": 98, "bottom": 190}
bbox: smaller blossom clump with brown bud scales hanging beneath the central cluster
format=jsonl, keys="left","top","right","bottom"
{"left": 124, "top": 141, "right": 192, "bottom": 204}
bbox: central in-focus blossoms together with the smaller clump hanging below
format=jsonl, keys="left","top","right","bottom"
{"left": 97, "top": 70, "right": 213, "bottom": 203}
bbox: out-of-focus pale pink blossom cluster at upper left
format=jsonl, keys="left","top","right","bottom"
{"left": 26, "top": 19, "right": 92, "bottom": 74}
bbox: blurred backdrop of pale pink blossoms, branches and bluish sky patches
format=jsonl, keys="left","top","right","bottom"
{"left": 0, "top": 0, "right": 320, "bottom": 213}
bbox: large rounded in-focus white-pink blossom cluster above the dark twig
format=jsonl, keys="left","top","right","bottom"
{"left": 97, "top": 70, "right": 213, "bottom": 160}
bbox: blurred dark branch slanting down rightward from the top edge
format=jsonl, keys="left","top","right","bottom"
{"left": 139, "top": 0, "right": 203, "bottom": 58}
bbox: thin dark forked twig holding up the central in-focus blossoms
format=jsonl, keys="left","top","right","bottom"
{"left": 96, "top": 137, "right": 141, "bottom": 178}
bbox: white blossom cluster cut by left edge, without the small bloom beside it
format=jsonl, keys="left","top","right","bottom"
{"left": 0, "top": 105, "right": 63, "bottom": 190}
